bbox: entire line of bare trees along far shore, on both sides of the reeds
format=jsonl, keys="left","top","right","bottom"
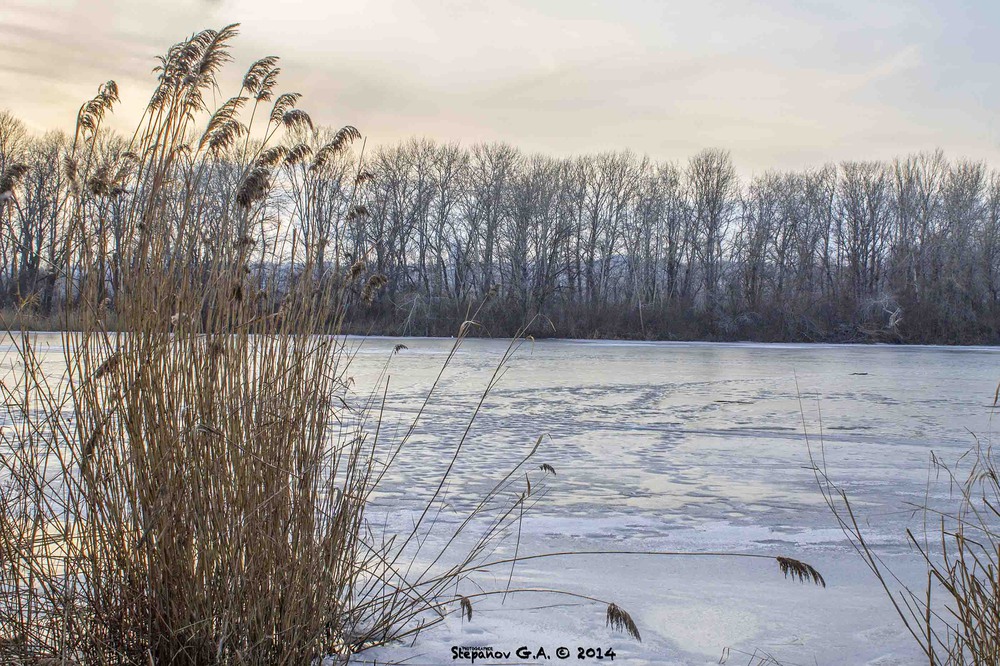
{"left": 0, "top": 106, "right": 1000, "bottom": 343}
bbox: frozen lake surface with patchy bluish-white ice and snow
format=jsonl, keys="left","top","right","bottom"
{"left": 0, "top": 335, "right": 1000, "bottom": 666}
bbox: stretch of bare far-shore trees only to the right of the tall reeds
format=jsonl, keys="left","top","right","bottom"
{"left": 343, "top": 141, "right": 1000, "bottom": 342}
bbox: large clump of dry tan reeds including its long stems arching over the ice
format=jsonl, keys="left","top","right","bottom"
{"left": 0, "top": 26, "right": 822, "bottom": 664}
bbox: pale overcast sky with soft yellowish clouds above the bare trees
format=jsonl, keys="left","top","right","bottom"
{"left": 0, "top": 0, "right": 1000, "bottom": 174}
